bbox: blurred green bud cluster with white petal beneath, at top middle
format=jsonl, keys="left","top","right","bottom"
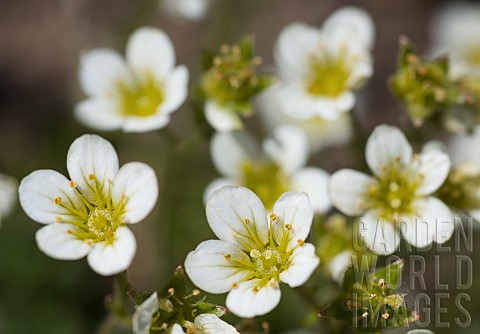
{"left": 201, "top": 37, "right": 271, "bottom": 132}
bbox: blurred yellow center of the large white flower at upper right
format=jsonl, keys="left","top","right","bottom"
{"left": 308, "top": 52, "right": 350, "bottom": 97}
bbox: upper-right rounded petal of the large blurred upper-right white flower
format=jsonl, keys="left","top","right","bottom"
{"left": 322, "top": 6, "right": 375, "bottom": 49}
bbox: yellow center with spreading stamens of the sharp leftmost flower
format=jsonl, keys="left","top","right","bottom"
{"left": 54, "top": 174, "right": 127, "bottom": 243}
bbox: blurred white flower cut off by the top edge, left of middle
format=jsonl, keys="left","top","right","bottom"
{"left": 160, "top": 0, "right": 212, "bottom": 21}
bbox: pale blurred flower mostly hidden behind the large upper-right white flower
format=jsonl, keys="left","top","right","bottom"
{"left": 255, "top": 83, "right": 352, "bottom": 153}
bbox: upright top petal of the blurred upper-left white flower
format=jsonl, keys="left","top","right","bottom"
{"left": 126, "top": 27, "right": 175, "bottom": 81}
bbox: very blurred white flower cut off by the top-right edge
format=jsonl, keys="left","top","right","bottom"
{"left": 431, "top": 1, "right": 480, "bottom": 79}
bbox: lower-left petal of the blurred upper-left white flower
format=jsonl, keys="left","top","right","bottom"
{"left": 75, "top": 98, "right": 124, "bottom": 131}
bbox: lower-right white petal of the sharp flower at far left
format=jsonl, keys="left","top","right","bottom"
{"left": 88, "top": 227, "right": 137, "bottom": 276}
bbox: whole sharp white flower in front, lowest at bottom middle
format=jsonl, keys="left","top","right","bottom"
{"left": 185, "top": 186, "right": 320, "bottom": 318}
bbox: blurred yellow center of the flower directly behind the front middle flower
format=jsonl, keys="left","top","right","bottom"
{"left": 241, "top": 163, "right": 289, "bottom": 210}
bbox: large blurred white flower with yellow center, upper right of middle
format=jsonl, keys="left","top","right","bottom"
{"left": 274, "top": 7, "right": 374, "bottom": 120}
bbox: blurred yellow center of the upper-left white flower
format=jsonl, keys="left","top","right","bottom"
{"left": 119, "top": 74, "right": 165, "bottom": 117}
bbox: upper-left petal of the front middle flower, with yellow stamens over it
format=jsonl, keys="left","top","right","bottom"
{"left": 206, "top": 186, "right": 268, "bottom": 249}
